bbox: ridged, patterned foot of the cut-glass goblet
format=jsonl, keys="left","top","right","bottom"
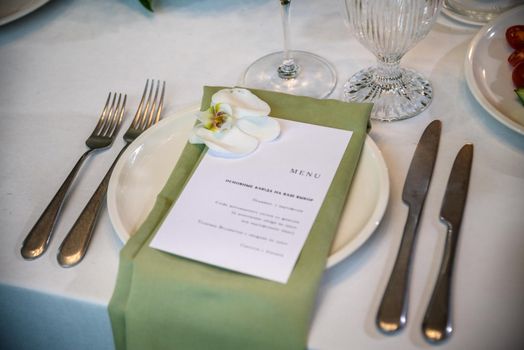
{"left": 343, "top": 67, "right": 433, "bottom": 122}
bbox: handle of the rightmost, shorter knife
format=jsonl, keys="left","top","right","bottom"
{"left": 422, "top": 224, "right": 458, "bottom": 342}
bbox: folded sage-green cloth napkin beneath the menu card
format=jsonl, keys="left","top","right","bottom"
{"left": 109, "top": 87, "right": 372, "bottom": 350}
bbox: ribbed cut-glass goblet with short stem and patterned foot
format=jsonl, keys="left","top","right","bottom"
{"left": 343, "top": 0, "right": 442, "bottom": 121}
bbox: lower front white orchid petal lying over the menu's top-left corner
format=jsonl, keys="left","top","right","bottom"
{"left": 190, "top": 126, "right": 258, "bottom": 158}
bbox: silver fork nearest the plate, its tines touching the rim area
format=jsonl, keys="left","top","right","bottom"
{"left": 57, "top": 79, "right": 166, "bottom": 267}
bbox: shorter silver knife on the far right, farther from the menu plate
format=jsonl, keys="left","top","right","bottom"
{"left": 422, "top": 144, "right": 473, "bottom": 342}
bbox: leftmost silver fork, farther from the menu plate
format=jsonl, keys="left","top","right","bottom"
{"left": 20, "top": 93, "right": 127, "bottom": 260}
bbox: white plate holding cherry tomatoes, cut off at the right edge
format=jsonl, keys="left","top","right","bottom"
{"left": 465, "top": 6, "right": 524, "bottom": 135}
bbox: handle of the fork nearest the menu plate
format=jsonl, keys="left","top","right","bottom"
{"left": 57, "top": 144, "right": 129, "bottom": 267}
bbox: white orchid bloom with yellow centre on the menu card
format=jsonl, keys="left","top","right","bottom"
{"left": 189, "top": 88, "right": 280, "bottom": 157}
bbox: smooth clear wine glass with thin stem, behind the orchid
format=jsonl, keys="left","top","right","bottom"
{"left": 240, "top": 0, "right": 337, "bottom": 98}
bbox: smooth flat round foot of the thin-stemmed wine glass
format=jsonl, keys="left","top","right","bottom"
{"left": 240, "top": 51, "right": 337, "bottom": 98}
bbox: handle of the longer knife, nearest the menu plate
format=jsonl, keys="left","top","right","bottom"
{"left": 376, "top": 207, "right": 422, "bottom": 334}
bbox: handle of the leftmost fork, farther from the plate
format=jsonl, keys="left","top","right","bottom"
{"left": 20, "top": 149, "right": 92, "bottom": 260}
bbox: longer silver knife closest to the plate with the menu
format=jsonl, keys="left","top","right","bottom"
{"left": 376, "top": 120, "right": 442, "bottom": 333}
